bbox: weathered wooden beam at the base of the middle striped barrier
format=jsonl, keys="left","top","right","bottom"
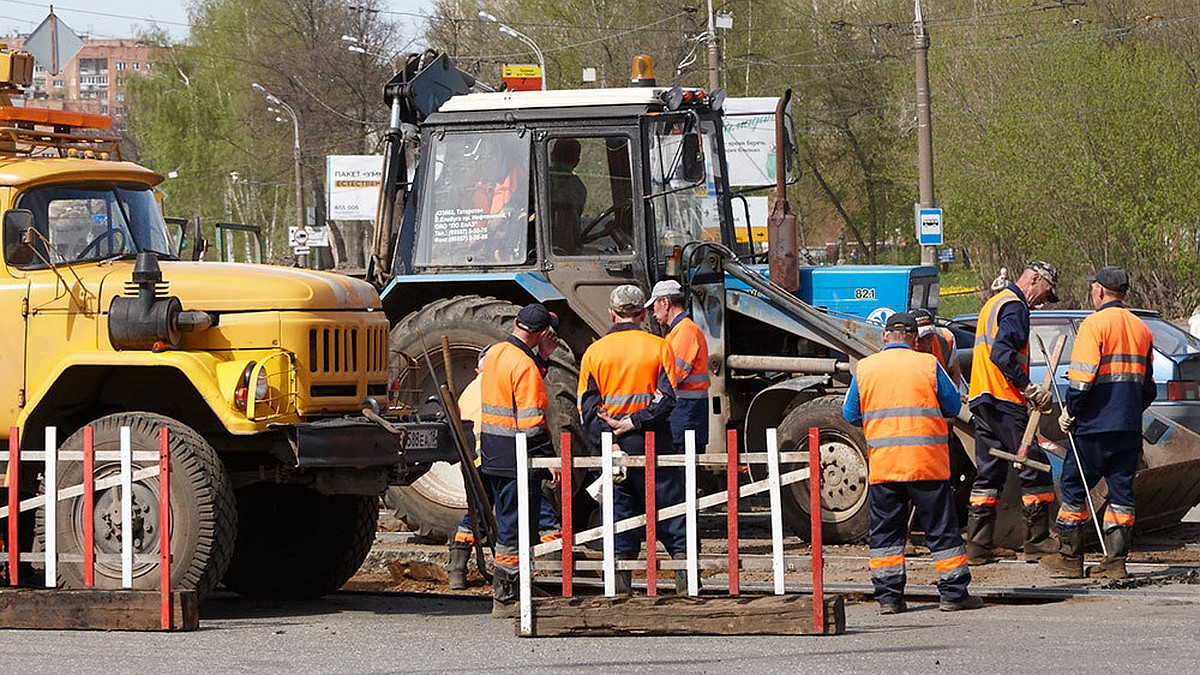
{"left": 517, "top": 595, "right": 846, "bottom": 638}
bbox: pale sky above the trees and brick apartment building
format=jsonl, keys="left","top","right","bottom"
{"left": 0, "top": 0, "right": 437, "bottom": 40}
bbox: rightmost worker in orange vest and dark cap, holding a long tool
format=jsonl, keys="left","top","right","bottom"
{"left": 1042, "top": 267, "right": 1157, "bottom": 579}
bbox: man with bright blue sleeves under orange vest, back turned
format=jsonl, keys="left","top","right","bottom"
{"left": 842, "top": 312, "right": 983, "bottom": 614}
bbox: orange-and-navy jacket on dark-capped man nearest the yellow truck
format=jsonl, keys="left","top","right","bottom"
{"left": 479, "top": 341, "right": 550, "bottom": 476}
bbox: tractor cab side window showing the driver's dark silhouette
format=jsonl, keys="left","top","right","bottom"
{"left": 546, "top": 136, "right": 635, "bottom": 256}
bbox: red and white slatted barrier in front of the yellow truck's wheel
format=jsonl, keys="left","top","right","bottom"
{"left": 0, "top": 426, "right": 173, "bottom": 629}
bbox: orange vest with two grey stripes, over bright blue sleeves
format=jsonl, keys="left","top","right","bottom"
{"left": 854, "top": 348, "right": 950, "bottom": 483}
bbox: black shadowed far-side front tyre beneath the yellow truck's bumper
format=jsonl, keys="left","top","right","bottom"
{"left": 224, "top": 483, "right": 379, "bottom": 599}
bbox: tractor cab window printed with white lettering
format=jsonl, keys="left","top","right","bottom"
{"left": 413, "top": 131, "right": 534, "bottom": 267}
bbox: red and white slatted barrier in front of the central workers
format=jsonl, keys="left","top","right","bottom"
{"left": 516, "top": 429, "right": 824, "bottom": 635}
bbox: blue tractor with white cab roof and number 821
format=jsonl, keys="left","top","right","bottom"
{"left": 372, "top": 53, "right": 937, "bottom": 542}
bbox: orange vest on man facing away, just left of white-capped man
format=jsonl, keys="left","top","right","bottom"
{"left": 577, "top": 330, "right": 676, "bottom": 418}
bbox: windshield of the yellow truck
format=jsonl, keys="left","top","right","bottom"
{"left": 5, "top": 185, "right": 174, "bottom": 269}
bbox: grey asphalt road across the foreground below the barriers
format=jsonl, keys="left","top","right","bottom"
{"left": 0, "top": 586, "right": 1200, "bottom": 675}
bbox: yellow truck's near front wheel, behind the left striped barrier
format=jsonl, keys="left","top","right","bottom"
{"left": 45, "top": 412, "right": 238, "bottom": 597}
